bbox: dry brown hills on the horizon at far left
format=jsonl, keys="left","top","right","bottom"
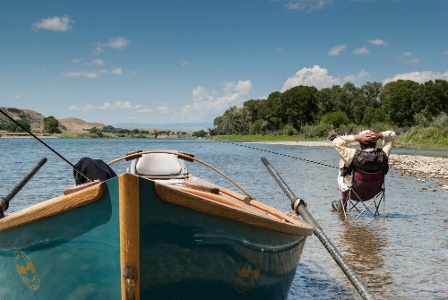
{"left": 0, "top": 107, "right": 105, "bottom": 133}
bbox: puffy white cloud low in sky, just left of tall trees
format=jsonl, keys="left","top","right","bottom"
{"left": 182, "top": 80, "right": 252, "bottom": 121}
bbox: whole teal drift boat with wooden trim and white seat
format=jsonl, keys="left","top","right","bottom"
{"left": 0, "top": 151, "right": 313, "bottom": 299}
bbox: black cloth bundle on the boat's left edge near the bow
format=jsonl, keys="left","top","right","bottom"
{"left": 73, "top": 157, "right": 117, "bottom": 185}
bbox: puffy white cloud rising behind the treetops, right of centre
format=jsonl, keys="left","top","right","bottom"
{"left": 281, "top": 65, "right": 340, "bottom": 92}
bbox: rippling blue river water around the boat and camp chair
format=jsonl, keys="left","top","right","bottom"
{"left": 0, "top": 138, "right": 448, "bottom": 300}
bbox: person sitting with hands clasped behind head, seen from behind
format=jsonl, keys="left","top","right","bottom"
{"left": 330, "top": 130, "right": 396, "bottom": 211}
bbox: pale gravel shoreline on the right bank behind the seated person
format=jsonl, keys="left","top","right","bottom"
{"left": 247, "top": 141, "right": 448, "bottom": 191}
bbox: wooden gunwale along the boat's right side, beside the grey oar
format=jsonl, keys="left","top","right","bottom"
{"left": 155, "top": 182, "right": 313, "bottom": 236}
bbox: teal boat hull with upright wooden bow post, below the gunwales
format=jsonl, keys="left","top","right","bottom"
{"left": 0, "top": 174, "right": 311, "bottom": 299}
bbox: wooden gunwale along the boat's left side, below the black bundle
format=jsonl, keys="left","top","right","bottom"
{"left": 0, "top": 182, "right": 106, "bottom": 232}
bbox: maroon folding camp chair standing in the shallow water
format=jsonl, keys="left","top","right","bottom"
{"left": 340, "top": 169, "right": 385, "bottom": 218}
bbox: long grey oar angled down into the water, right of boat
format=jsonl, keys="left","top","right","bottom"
{"left": 261, "top": 157, "right": 373, "bottom": 299}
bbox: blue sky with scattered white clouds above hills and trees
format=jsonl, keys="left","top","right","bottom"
{"left": 0, "top": 0, "right": 448, "bottom": 125}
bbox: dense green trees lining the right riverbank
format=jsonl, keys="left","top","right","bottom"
{"left": 209, "top": 79, "right": 448, "bottom": 136}
